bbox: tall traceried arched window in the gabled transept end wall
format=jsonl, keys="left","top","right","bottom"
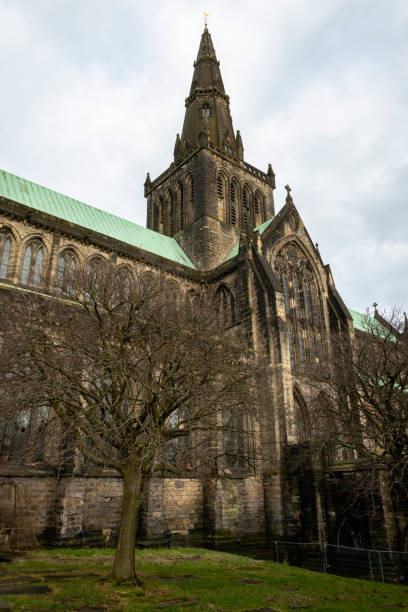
{"left": 275, "top": 243, "right": 322, "bottom": 374}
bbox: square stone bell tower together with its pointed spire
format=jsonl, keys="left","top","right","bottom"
{"left": 144, "top": 26, "right": 275, "bottom": 270}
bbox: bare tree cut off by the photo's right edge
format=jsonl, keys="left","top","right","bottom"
{"left": 311, "top": 309, "right": 408, "bottom": 545}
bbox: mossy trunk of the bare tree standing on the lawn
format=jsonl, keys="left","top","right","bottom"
{"left": 113, "top": 466, "right": 142, "bottom": 585}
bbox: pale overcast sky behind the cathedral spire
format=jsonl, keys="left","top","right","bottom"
{"left": 0, "top": 0, "right": 408, "bottom": 311}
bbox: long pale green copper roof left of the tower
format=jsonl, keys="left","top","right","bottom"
{"left": 0, "top": 170, "right": 195, "bottom": 268}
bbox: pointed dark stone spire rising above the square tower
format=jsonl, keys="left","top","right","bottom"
{"left": 179, "top": 26, "right": 243, "bottom": 161}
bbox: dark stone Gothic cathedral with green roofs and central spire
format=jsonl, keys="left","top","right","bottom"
{"left": 0, "top": 27, "right": 396, "bottom": 545}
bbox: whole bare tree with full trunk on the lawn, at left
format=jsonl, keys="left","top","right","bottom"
{"left": 0, "top": 265, "right": 258, "bottom": 583}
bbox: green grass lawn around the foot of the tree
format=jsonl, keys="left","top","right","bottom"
{"left": 0, "top": 548, "right": 408, "bottom": 612}
